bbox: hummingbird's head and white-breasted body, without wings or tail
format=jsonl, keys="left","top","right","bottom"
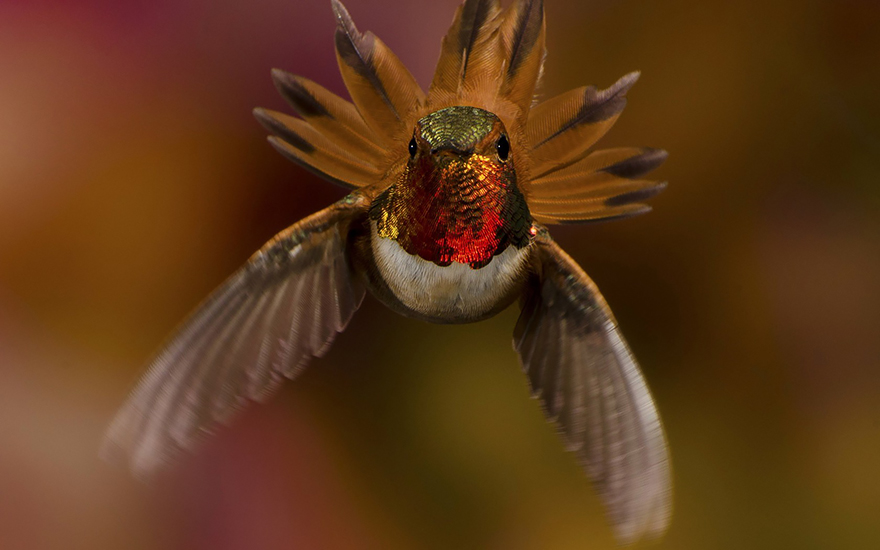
{"left": 360, "top": 106, "right": 533, "bottom": 323}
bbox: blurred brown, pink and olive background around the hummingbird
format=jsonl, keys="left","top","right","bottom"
{"left": 0, "top": 0, "right": 880, "bottom": 549}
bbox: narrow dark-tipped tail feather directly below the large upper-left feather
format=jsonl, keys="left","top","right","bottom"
{"left": 272, "top": 69, "right": 383, "bottom": 159}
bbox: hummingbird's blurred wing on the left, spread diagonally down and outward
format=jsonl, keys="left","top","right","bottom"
{"left": 102, "top": 194, "right": 369, "bottom": 476}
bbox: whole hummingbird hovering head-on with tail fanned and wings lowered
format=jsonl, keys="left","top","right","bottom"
{"left": 103, "top": 0, "right": 672, "bottom": 543}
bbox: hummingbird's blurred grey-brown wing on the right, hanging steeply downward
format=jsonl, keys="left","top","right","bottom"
{"left": 514, "top": 231, "right": 672, "bottom": 542}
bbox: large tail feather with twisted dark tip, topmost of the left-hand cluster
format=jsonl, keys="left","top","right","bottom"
{"left": 332, "top": 0, "right": 425, "bottom": 143}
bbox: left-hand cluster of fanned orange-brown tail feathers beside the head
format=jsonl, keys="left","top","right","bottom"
{"left": 254, "top": 0, "right": 425, "bottom": 188}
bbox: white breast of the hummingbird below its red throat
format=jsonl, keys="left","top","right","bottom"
{"left": 371, "top": 223, "right": 528, "bottom": 318}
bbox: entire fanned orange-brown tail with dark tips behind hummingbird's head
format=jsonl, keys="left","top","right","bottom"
{"left": 255, "top": 0, "right": 666, "bottom": 223}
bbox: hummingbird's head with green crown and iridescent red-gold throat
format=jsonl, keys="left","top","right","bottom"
{"left": 371, "top": 106, "right": 532, "bottom": 269}
